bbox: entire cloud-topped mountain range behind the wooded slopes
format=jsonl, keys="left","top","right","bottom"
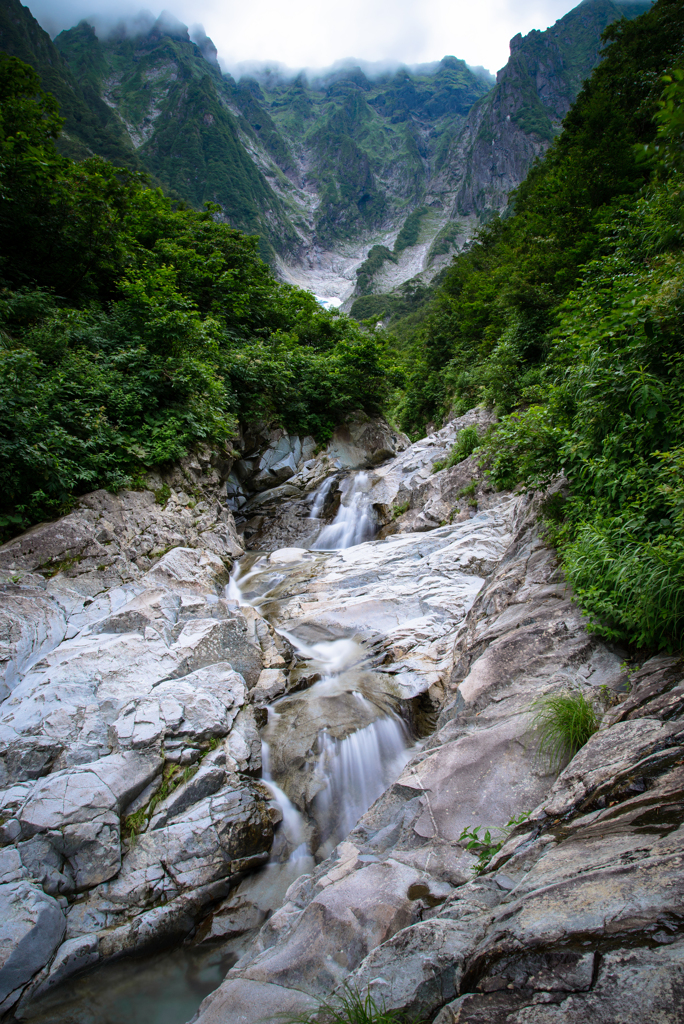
{"left": 0, "top": 0, "right": 649, "bottom": 288}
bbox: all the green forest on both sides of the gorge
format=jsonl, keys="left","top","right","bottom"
{"left": 0, "top": 0, "right": 684, "bottom": 650}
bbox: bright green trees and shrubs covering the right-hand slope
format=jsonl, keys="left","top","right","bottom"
{"left": 389, "top": 0, "right": 684, "bottom": 649}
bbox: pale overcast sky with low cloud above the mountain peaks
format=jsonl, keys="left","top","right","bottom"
{"left": 31, "top": 0, "right": 576, "bottom": 72}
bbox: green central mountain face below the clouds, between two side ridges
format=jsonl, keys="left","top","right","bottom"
{"left": 236, "top": 57, "right": 490, "bottom": 245}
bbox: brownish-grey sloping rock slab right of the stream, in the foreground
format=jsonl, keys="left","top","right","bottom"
{"left": 192, "top": 487, "right": 684, "bottom": 1024}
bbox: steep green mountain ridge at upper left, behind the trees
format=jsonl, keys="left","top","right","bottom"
{"left": 55, "top": 20, "right": 299, "bottom": 262}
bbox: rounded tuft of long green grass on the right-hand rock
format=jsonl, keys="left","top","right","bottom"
{"left": 530, "top": 690, "right": 599, "bottom": 770}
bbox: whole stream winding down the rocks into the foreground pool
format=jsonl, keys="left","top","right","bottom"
{"left": 18, "top": 471, "right": 416, "bottom": 1024}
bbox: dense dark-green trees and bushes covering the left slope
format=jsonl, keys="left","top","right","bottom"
{"left": 0, "top": 55, "right": 396, "bottom": 532}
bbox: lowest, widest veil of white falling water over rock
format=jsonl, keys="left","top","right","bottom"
{"left": 313, "top": 712, "right": 411, "bottom": 850}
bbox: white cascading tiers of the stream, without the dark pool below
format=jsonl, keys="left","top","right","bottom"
{"left": 225, "top": 487, "right": 413, "bottom": 864}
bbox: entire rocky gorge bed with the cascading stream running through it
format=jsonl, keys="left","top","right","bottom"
{"left": 0, "top": 410, "right": 684, "bottom": 1024}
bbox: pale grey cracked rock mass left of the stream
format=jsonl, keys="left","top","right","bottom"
{"left": 0, "top": 475, "right": 287, "bottom": 1016}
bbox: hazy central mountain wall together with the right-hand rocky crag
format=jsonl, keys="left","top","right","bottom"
{"left": 215, "top": 0, "right": 650, "bottom": 299}
